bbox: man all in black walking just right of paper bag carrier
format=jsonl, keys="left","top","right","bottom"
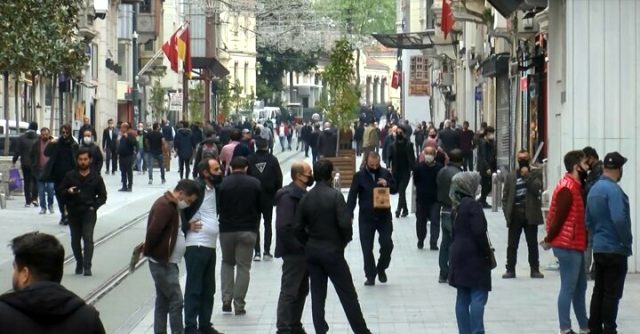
{"left": 389, "top": 127, "right": 416, "bottom": 218}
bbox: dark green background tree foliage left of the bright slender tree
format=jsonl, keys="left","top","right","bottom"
{"left": 256, "top": 47, "right": 319, "bottom": 105}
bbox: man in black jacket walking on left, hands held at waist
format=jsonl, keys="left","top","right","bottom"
{"left": 58, "top": 148, "right": 107, "bottom": 276}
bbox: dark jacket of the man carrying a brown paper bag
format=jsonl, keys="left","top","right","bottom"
{"left": 347, "top": 167, "right": 398, "bottom": 223}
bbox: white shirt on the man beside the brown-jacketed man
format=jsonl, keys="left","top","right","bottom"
{"left": 186, "top": 185, "right": 220, "bottom": 248}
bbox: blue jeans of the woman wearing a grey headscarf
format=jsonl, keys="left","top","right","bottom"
{"left": 456, "top": 288, "right": 489, "bottom": 334}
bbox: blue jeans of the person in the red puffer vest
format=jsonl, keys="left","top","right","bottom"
{"left": 553, "top": 247, "right": 588, "bottom": 331}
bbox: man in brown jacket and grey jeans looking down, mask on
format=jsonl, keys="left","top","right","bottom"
{"left": 143, "top": 180, "right": 200, "bottom": 333}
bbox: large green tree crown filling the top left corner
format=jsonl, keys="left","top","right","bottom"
{"left": 0, "top": 0, "right": 88, "bottom": 78}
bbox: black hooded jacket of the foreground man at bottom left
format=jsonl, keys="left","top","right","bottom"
{"left": 0, "top": 282, "right": 105, "bottom": 334}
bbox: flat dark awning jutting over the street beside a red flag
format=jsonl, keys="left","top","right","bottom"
{"left": 372, "top": 29, "right": 457, "bottom": 50}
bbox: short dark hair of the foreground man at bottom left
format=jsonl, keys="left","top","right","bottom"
{"left": 11, "top": 232, "right": 64, "bottom": 283}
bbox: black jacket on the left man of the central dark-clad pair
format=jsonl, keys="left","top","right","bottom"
{"left": 274, "top": 182, "right": 307, "bottom": 257}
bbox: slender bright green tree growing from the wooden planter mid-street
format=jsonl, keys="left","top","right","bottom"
{"left": 320, "top": 39, "right": 358, "bottom": 130}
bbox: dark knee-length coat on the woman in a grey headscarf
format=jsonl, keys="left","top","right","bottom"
{"left": 449, "top": 197, "right": 492, "bottom": 291}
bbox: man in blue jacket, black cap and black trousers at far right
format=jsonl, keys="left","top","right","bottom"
{"left": 586, "top": 152, "right": 633, "bottom": 334}
